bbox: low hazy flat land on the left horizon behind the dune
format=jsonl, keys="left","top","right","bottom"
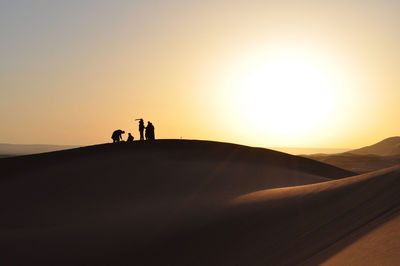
{"left": 0, "top": 143, "right": 78, "bottom": 158}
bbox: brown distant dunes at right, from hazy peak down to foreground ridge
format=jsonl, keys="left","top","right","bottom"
{"left": 303, "top": 137, "right": 400, "bottom": 173}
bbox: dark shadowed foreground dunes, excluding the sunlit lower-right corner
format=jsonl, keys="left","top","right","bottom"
{"left": 0, "top": 140, "right": 400, "bottom": 265}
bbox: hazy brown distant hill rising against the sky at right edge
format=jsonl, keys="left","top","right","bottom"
{"left": 348, "top": 137, "right": 400, "bottom": 156}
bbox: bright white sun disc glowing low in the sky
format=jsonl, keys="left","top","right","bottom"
{"left": 236, "top": 58, "right": 335, "bottom": 135}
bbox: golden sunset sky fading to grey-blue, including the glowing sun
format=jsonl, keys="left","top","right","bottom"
{"left": 0, "top": 0, "right": 400, "bottom": 148}
